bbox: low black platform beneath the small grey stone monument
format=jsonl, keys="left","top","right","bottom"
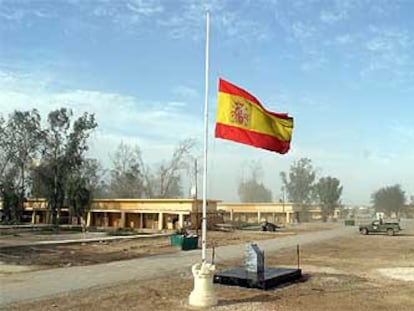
{"left": 213, "top": 267, "right": 302, "bottom": 290}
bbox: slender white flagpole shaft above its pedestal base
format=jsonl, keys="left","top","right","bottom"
{"left": 201, "top": 11, "right": 210, "bottom": 262}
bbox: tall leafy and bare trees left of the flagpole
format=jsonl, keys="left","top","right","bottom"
{"left": 0, "top": 108, "right": 196, "bottom": 224}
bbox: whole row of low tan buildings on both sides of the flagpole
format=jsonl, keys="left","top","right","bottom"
{"left": 0, "top": 199, "right": 340, "bottom": 230}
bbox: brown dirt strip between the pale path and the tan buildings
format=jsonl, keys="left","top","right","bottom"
{"left": 0, "top": 223, "right": 339, "bottom": 273}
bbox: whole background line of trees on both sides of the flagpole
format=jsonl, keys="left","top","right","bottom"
{"left": 0, "top": 108, "right": 414, "bottom": 224}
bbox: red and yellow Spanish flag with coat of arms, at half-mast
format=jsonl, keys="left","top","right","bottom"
{"left": 215, "top": 79, "right": 293, "bottom": 154}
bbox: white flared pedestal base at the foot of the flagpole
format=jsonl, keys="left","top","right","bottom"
{"left": 189, "top": 262, "right": 218, "bottom": 307}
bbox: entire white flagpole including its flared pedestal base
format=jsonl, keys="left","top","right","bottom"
{"left": 189, "top": 11, "right": 218, "bottom": 307}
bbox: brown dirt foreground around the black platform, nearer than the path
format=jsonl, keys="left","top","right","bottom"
{"left": 2, "top": 221, "right": 414, "bottom": 311}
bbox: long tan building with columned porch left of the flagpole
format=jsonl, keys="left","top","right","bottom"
{"left": 15, "top": 199, "right": 218, "bottom": 230}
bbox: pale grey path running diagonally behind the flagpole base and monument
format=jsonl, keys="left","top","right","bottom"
{"left": 0, "top": 227, "right": 356, "bottom": 308}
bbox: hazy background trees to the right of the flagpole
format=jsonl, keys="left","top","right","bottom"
{"left": 238, "top": 158, "right": 414, "bottom": 221}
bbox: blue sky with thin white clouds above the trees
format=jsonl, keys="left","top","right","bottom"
{"left": 0, "top": 0, "right": 414, "bottom": 205}
